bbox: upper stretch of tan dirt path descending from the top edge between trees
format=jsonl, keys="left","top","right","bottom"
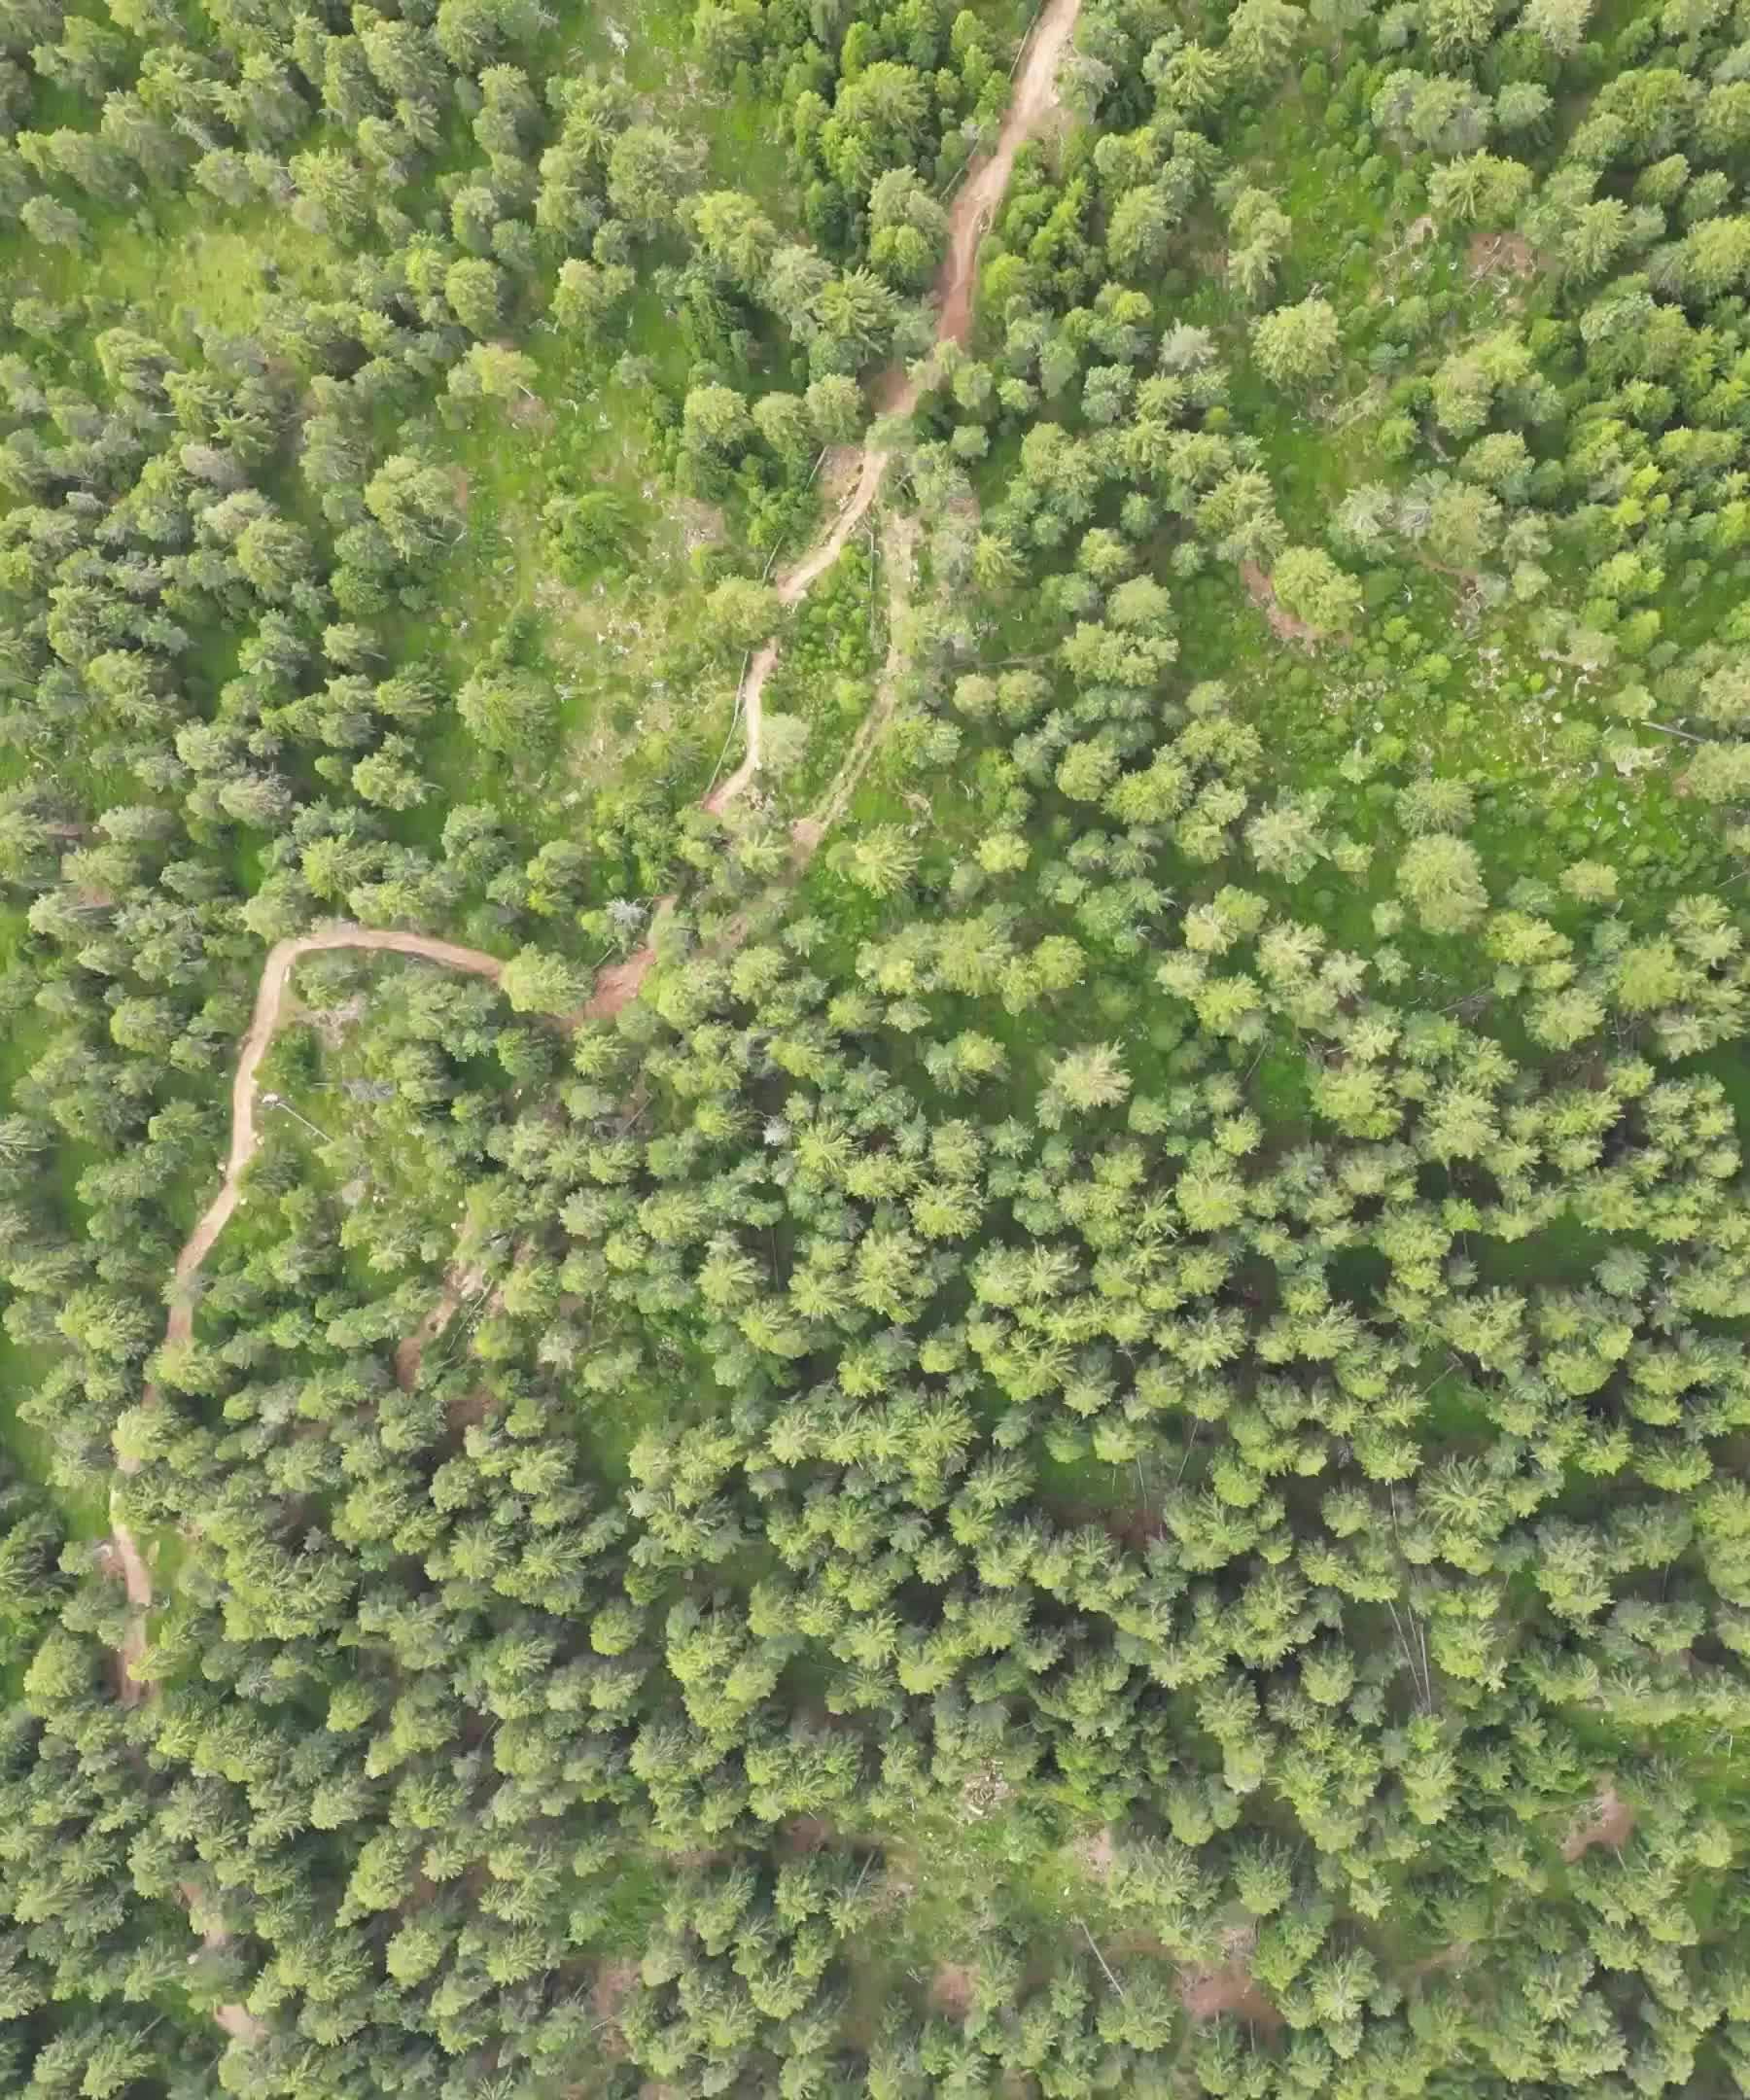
{"left": 704, "top": 0, "right": 1082, "bottom": 829}
